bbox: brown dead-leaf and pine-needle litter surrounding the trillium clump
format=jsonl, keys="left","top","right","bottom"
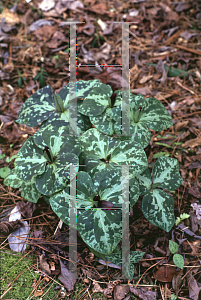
{"left": 0, "top": 0, "right": 201, "bottom": 300}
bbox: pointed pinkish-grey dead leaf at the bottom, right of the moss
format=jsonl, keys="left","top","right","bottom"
{"left": 58, "top": 258, "right": 77, "bottom": 292}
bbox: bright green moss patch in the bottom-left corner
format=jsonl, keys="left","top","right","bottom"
{"left": 0, "top": 250, "right": 58, "bottom": 300}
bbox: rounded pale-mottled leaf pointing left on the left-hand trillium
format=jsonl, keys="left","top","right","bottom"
{"left": 15, "top": 149, "right": 47, "bottom": 181}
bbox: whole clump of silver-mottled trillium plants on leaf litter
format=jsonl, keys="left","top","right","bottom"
{"left": 4, "top": 80, "right": 183, "bottom": 278}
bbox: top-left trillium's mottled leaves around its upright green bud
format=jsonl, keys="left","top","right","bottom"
{"left": 16, "top": 80, "right": 100, "bottom": 134}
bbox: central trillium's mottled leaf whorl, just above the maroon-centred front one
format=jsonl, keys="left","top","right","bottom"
{"left": 80, "top": 128, "right": 148, "bottom": 176}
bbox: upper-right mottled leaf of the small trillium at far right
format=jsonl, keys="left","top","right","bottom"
{"left": 152, "top": 156, "right": 183, "bottom": 191}
